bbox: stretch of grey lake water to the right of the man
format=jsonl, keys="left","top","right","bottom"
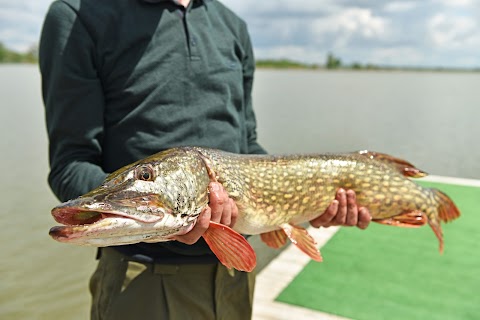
{"left": 254, "top": 70, "right": 480, "bottom": 179}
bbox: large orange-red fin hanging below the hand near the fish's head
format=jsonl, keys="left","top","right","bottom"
{"left": 203, "top": 221, "right": 257, "bottom": 272}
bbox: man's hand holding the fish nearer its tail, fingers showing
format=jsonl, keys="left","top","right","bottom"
{"left": 310, "top": 189, "right": 372, "bottom": 229}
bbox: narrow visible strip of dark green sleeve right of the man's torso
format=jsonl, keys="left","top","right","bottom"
{"left": 243, "top": 26, "right": 267, "bottom": 154}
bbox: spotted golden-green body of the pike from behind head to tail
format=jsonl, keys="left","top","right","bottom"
{"left": 197, "top": 149, "right": 457, "bottom": 245}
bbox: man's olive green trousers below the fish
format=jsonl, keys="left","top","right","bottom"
{"left": 90, "top": 248, "right": 255, "bottom": 320}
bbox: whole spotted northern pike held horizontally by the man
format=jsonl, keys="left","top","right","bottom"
{"left": 50, "top": 147, "right": 460, "bottom": 271}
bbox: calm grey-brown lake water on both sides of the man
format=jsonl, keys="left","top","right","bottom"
{"left": 0, "top": 65, "right": 480, "bottom": 319}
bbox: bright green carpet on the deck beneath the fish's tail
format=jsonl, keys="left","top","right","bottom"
{"left": 277, "top": 182, "right": 480, "bottom": 320}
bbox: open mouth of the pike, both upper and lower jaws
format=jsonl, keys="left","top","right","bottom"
{"left": 49, "top": 200, "right": 196, "bottom": 247}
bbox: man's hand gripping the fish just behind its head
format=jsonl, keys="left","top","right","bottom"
{"left": 174, "top": 182, "right": 238, "bottom": 244}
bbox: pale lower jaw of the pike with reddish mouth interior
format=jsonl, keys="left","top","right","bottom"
{"left": 49, "top": 208, "right": 196, "bottom": 247}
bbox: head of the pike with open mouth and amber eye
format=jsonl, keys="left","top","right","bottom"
{"left": 50, "top": 149, "right": 209, "bottom": 246}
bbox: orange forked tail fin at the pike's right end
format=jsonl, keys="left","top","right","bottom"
{"left": 428, "top": 189, "right": 460, "bottom": 253}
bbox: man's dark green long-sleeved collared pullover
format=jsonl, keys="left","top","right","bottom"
{"left": 40, "top": 0, "right": 265, "bottom": 262}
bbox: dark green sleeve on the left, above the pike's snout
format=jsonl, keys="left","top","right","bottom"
{"left": 39, "top": 1, "right": 106, "bottom": 201}
